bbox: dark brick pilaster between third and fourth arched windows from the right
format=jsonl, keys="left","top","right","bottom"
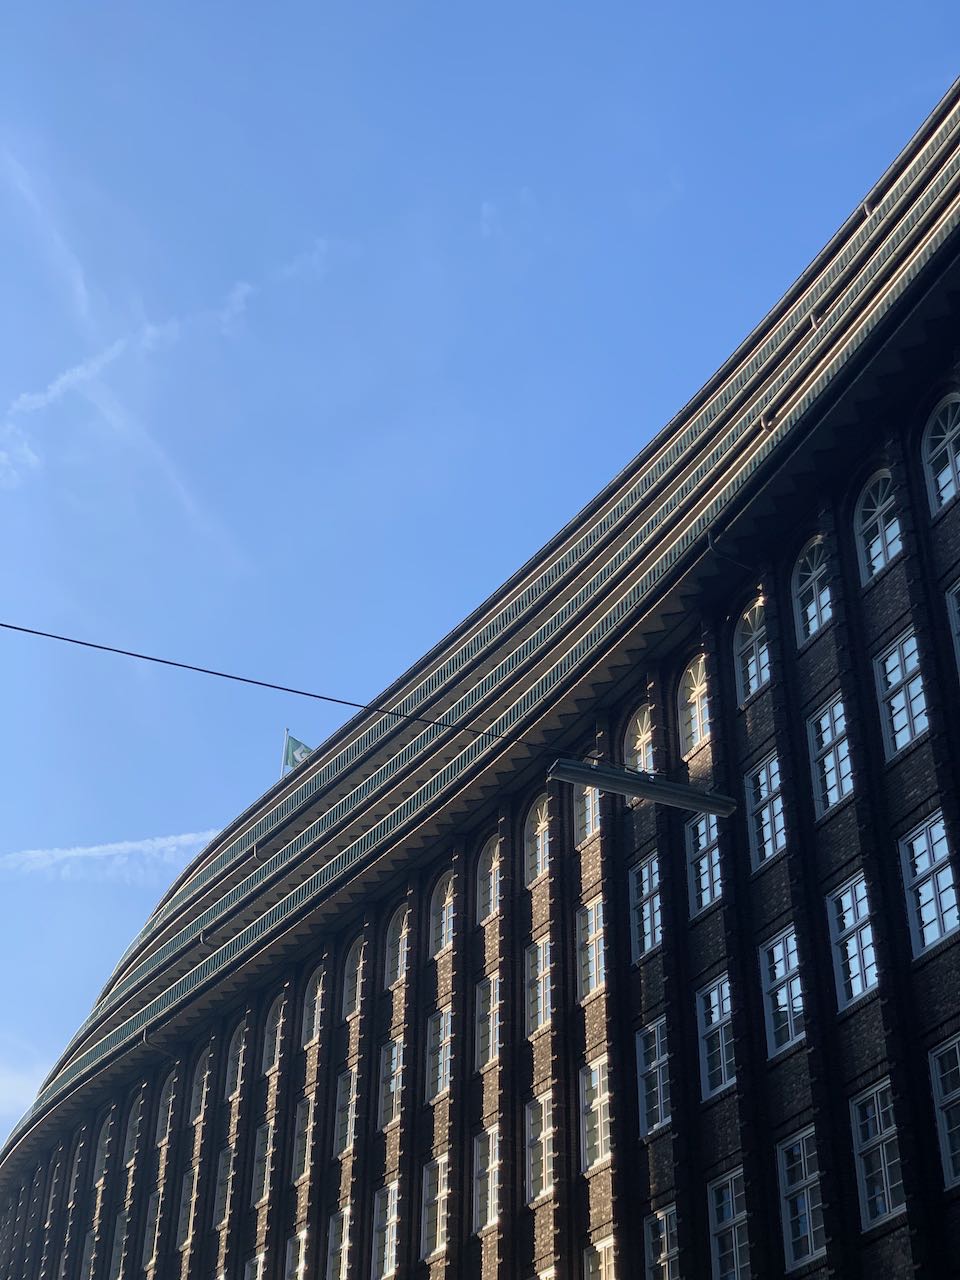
{"left": 760, "top": 566, "right": 858, "bottom": 1276}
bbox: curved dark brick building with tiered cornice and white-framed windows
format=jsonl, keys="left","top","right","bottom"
{"left": 0, "top": 87, "right": 960, "bottom": 1280}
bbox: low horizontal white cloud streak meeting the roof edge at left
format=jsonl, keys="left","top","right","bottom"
{"left": 0, "top": 829, "right": 216, "bottom": 883}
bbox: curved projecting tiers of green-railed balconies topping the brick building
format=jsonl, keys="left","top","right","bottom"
{"left": 5, "top": 72, "right": 960, "bottom": 1177}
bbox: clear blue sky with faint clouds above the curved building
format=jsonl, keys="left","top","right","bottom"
{"left": 0, "top": 0, "right": 960, "bottom": 1130}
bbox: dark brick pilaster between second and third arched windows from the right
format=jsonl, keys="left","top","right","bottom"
{"left": 823, "top": 508, "right": 942, "bottom": 1274}
